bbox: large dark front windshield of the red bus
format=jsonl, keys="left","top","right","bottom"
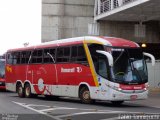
{"left": 111, "top": 48, "right": 148, "bottom": 84}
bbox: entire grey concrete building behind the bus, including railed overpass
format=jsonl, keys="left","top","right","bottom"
{"left": 42, "top": 0, "right": 160, "bottom": 43}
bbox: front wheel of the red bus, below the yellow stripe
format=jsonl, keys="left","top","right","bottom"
{"left": 79, "top": 87, "right": 92, "bottom": 104}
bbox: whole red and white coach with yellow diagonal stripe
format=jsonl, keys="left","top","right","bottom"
{"left": 6, "top": 36, "right": 155, "bottom": 104}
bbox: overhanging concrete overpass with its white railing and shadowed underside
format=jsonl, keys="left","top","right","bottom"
{"left": 94, "top": 0, "right": 160, "bottom": 22}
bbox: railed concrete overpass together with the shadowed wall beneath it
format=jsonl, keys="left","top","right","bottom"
{"left": 94, "top": 0, "right": 160, "bottom": 43}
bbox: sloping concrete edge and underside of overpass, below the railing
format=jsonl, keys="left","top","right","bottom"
{"left": 97, "top": 0, "right": 160, "bottom": 22}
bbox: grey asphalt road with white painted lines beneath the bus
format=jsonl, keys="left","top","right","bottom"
{"left": 0, "top": 92, "right": 160, "bottom": 120}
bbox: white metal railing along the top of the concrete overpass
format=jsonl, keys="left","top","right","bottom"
{"left": 95, "top": 0, "right": 137, "bottom": 16}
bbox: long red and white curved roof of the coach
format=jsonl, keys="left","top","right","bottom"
{"left": 8, "top": 36, "right": 139, "bottom": 52}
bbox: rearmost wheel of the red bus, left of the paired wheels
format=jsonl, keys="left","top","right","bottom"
{"left": 16, "top": 81, "right": 24, "bottom": 98}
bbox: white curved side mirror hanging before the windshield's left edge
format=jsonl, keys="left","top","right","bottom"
{"left": 96, "top": 50, "right": 113, "bottom": 67}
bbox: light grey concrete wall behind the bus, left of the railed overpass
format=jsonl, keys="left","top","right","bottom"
{"left": 42, "top": 0, "right": 95, "bottom": 42}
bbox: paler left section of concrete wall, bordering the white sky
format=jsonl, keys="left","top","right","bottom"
{"left": 42, "top": 0, "right": 65, "bottom": 42}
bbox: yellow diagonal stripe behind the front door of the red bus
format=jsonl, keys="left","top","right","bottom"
{"left": 83, "top": 42, "right": 99, "bottom": 87}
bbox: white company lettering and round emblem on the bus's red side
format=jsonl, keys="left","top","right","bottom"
{"left": 61, "top": 67, "right": 82, "bottom": 73}
